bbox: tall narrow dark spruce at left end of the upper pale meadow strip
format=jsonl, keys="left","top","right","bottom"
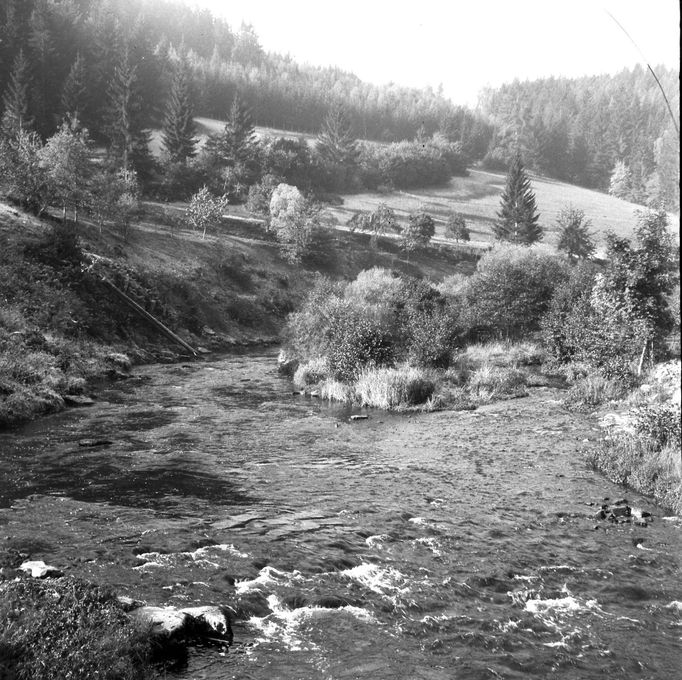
{"left": 162, "top": 63, "right": 197, "bottom": 164}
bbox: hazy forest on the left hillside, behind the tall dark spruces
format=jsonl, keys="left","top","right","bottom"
{"left": 0, "top": 0, "right": 491, "bottom": 149}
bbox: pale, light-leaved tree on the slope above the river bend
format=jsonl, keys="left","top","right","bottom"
{"left": 268, "top": 184, "right": 320, "bottom": 263}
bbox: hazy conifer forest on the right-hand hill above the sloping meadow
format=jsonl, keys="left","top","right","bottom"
{"left": 481, "top": 65, "right": 680, "bottom": 210}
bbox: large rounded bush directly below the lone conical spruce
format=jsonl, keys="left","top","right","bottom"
{"left": 464, "top": 246, "right": 567, "bottom": 336}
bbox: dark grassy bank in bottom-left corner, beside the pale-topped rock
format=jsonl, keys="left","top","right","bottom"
{"left": 0, "top": 578, "right": 159, "bottom": 680}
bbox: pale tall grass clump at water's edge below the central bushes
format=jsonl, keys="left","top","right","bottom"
{"left": 355, "top": 366, "right": 436, "bottom": 409}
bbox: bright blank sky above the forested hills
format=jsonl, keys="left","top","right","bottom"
{"left": 185, "top": 0, "right": 680, "bottom": 105}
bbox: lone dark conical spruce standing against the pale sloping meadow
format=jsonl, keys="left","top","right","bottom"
{"left": 493, "top": 153, "right": 543, "bottom": 245}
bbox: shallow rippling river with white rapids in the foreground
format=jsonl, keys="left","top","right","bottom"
{"left": 0, "top": 355, "right": 682, "bottom": 680}
